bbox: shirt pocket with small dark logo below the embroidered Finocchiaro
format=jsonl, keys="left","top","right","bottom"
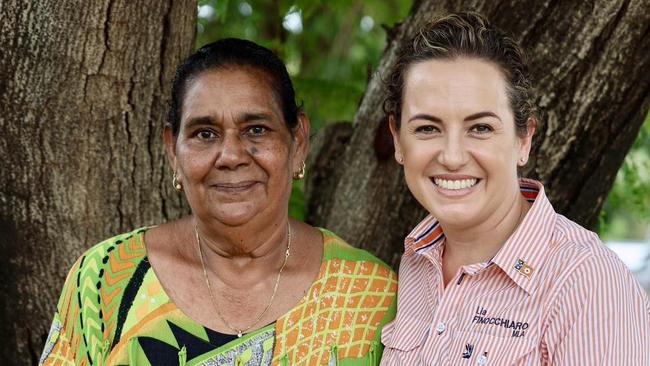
{"left": 445, "top": 332, "right": 541, "bottom": 366}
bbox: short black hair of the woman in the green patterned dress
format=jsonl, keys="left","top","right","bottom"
{"left": 167, "top": 38, "right": 302, "bottom": 136}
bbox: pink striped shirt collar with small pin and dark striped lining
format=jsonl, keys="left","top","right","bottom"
{"left": 404, "top": 179, "right": 556, "bottom": 294}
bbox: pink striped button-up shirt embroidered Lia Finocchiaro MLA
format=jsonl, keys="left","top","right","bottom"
{"left": 381, "top": 179, "right": 650, "bottom": 366}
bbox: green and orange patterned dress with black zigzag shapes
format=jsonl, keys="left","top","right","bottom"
{"left": 40, "top": 229, "right": 397, "bottom": 366}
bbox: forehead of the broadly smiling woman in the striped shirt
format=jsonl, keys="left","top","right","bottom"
{"left": 403, "top": 58, "right": 510, "bottom": 113}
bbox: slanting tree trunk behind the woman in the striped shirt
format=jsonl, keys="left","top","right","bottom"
{"left": 306, "top": 0, "right": 650, "bottom": 265}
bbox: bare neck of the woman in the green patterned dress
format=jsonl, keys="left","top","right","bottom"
{"left": 191, "top": 217, "right": 293, "bottom": 288}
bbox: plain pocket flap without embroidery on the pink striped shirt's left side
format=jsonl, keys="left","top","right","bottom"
{"left": 381, "top": 316, "right": 431, "bottom": 360}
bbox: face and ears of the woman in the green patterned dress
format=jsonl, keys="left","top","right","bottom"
{"left": 165, "top": 67, "right": 309, "bottom": 226}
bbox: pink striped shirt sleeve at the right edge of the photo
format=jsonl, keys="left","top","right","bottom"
{"left": 543, "top": 254, "right": 650, "bottom": 366}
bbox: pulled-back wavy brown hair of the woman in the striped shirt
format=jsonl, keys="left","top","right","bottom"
{"left": 384, "top": 12, "right": 534, "bottom": 136}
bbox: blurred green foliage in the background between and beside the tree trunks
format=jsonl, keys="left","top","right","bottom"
{"left": 196, "top": 0, "right": 650, "bottom": 241}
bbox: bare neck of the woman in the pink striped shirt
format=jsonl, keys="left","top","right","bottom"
{"left": 440, "top": 191, "right": 530, "bottom": 277}
